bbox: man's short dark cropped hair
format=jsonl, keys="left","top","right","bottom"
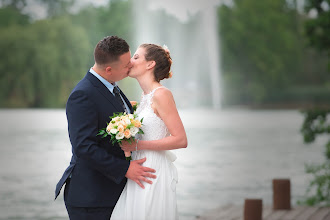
{"left": 94, "top": 36, "right": 129, "bottom": 65}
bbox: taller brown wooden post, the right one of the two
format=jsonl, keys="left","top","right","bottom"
{"left": 273, "top": 179, "right": 291, "bottom": 210}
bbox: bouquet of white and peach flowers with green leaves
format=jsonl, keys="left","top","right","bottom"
{"left": 97, "top": 112, "right": 144, "bottom": 160}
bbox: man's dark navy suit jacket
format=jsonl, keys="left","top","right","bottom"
{"left": 55, "top": 72, "right": 133, "bottom": 207}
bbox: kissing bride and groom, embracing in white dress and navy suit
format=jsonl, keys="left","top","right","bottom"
{"left": 55, "top": 36, "right": 187, "bottom": 220}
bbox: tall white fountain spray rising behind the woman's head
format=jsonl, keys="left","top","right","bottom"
{"left": 132, "top": 0, "right": 221, "bottom": 109}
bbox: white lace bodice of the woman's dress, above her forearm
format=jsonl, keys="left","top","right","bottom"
{"left": 136, "top": 86, "right": 170, "bottom": 140}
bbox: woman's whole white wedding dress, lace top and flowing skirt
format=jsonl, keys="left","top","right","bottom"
{"left": 111, "top": 86, "right": 178, "bottom": 220}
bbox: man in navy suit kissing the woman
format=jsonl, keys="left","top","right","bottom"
{"left": 55, "top": 36, "right": 156, "bottom": 220}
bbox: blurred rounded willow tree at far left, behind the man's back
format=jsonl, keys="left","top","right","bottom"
{"left": 0, "top": 18, "right": 89, "bottom": 107}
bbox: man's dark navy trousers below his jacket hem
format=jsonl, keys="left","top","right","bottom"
{"left": 64, "top": 178, "right": 114, "bottom": 220}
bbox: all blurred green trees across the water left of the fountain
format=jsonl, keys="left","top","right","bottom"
{"left": 0, "top": 0, "right": 133, "bottom": 107}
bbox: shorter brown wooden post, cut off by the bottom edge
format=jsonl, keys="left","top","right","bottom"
{"left": 244, "top": 199, "right": 262, "bottom": 220}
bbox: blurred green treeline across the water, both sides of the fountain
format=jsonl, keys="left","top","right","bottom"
{"left": 0, "top": 0, "right": 330, "bottom": 107}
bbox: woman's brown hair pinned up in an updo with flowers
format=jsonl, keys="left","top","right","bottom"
{"left": 140, "top": 44, "right": 172, "bottom": 82}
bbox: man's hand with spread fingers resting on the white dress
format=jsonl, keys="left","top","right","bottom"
{"left": 125, "top": 158, "right": 156, "bottom": 189}
